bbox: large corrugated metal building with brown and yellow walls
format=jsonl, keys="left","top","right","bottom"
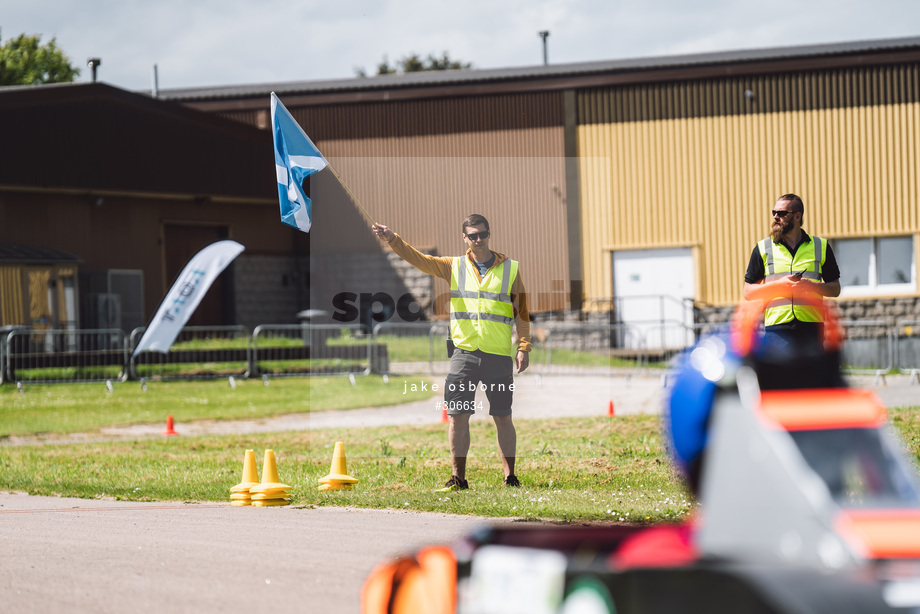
{"left": 161, "top": 38, "right": 920, "bottom": 332}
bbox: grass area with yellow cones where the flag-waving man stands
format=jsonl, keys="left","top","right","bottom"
{"left": 0, "top": 416, "right": 692, "bottom": 522}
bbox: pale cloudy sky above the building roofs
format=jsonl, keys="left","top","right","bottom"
{"left": 0, "top": 0, "right": 920, "bottom": 90}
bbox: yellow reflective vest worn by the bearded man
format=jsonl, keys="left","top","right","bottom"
{"left": 757, "top": 235, "right": 827, "bottom": 326}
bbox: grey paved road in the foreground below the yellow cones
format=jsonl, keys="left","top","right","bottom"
{"left": 0, "top": 493, "right": 504, "bottom": 614}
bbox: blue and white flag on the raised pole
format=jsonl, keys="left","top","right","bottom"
{"left": 272, "top": 92, "right": 329, "bottom": 232}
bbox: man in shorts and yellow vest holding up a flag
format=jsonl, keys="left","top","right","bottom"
{"left": 371, "top": 214, "right": 531, "bottom": 492}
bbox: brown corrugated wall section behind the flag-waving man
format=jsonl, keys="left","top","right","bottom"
{"left": 290, "top": 93, "right": 569, "bottom": 318}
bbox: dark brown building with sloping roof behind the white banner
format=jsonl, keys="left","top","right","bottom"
{"left": 0, "top": 83, "right": 309, "bottom": 332}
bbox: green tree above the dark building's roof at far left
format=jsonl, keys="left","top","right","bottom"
{"left": 0, "top": 34, "right": 80, "bottom": 85}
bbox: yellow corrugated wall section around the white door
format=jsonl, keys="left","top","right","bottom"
{"left": 578, "top": 65, "right": 920, "bottom": 305}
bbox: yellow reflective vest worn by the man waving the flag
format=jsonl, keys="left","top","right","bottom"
{"left": 450, "top": 256, "right": 518, "bottom": 356}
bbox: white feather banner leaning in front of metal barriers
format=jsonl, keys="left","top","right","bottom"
{"left": 131, "top": 241, "right": 245, "bottom": 358}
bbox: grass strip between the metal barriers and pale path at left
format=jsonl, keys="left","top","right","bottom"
{"left": 0, "top": 375, "right": 431, "bottom": 437}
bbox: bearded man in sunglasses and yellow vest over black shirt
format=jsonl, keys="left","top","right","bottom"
{"left": 744, "top": 194, "right": 840, "bottom": 347}
